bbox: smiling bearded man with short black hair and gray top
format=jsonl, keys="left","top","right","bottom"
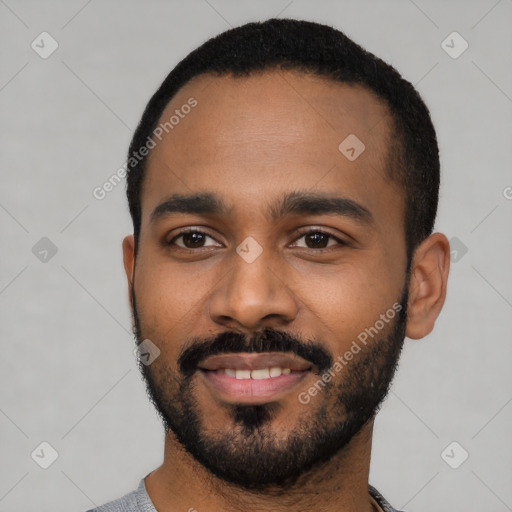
{"left": 87, "top": 19, "right": 449, "bottom": 512}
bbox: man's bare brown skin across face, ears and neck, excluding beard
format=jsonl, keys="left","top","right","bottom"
{"left": 123, "top": 71, "right": 449, "bottom": 512}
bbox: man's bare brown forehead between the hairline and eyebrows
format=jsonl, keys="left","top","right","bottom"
{"left": 142, "top": 71, "right": 402, "bottom": 232}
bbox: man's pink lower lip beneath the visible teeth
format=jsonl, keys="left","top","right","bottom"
{"left": 199, "top": 370, "right": 309, "bottom": 404}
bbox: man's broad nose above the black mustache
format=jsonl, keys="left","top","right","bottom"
{"left": 209, "top": 247, "right": 298, "bottom": 332}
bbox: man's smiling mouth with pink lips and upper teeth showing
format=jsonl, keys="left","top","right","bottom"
{"left": 198, "top": 352, "right": 313, "bottom": 404}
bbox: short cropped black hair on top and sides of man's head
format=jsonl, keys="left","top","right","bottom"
{"left": 127, "top": 19, "right": 440, "bottom": 268}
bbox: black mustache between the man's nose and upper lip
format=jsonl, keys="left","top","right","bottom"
{"left": 178, "top": 329, "right": 333, "bottom": 377}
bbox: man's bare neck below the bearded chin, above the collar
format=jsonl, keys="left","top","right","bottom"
{"left": 145, "top": 423, "right": 374, "bottom": 512}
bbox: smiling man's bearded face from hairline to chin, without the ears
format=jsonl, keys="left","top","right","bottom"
{"left": 127, "top": 72, "right": 408, "bottom": 489}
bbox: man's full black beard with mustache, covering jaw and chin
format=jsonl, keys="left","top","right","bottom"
{"left": 132, "top": 280, "right": 408, "bottom": 492}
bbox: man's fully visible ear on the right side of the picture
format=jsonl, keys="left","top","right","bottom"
{"left": 405, "top": 233, "right": 450, "bottom": 340}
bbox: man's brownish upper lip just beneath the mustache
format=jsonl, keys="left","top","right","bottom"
{"left": 198, "top": 352, "right": 313, "bottom": 371}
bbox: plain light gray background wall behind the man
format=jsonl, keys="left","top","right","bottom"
{"left": 0, "top": 0, "right": 512, "bottom": 512}
